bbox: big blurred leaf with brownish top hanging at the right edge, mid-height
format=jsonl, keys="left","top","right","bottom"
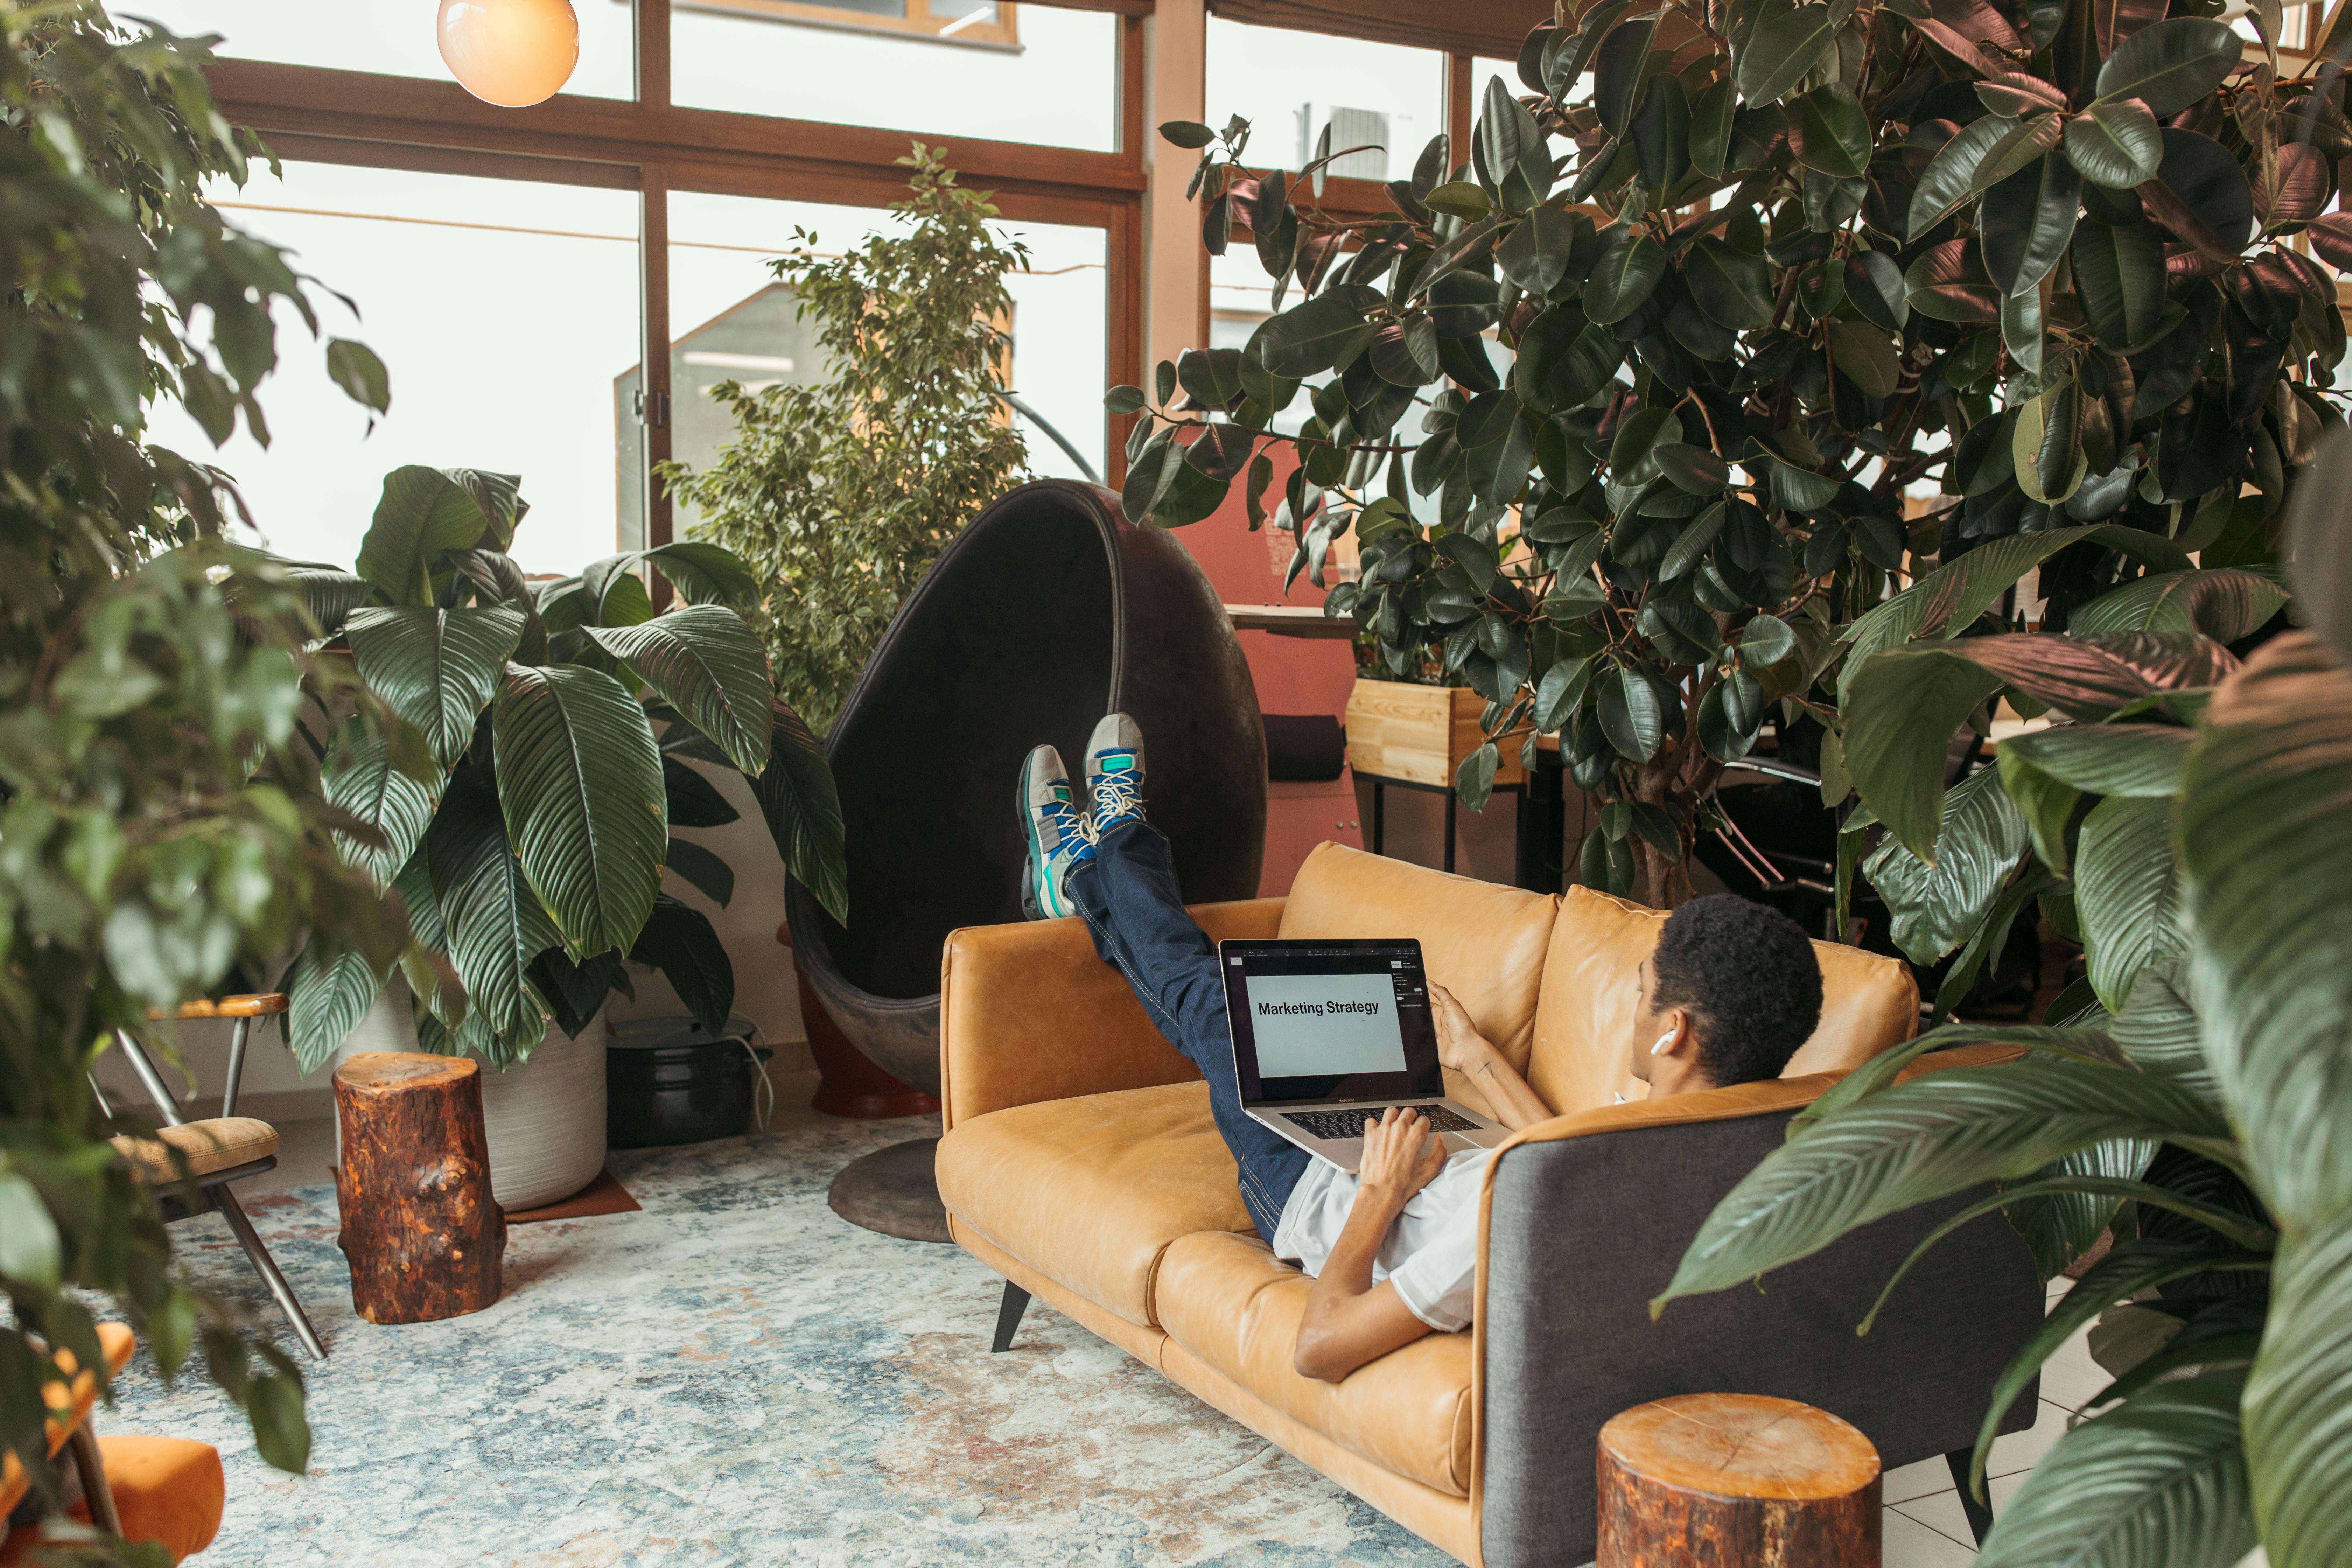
{"left": 2180, "top": 632, "right": 2352, "bottom": 1230}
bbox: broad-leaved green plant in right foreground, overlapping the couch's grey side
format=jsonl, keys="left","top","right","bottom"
{"left": 1658, "top": 426, "right": 2352, "bottom": 1568}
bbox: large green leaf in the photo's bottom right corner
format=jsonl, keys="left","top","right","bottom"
{"left": 2239, "top": 1203, "right": 2352, "bottom": 1568}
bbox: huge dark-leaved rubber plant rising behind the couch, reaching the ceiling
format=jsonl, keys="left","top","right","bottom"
{"left": 1129, "top": 0, "right": 2352, "bottom": 905}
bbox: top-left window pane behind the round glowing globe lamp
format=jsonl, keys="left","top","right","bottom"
{"left": 113, "top": 0, "right": 637, "bottom": 99}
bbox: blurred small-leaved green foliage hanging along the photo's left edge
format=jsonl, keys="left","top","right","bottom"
{"left": 0, "top": 0, "right": 400, "bottom": 1523}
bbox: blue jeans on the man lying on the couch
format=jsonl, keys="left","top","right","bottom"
{"left": 1065, "top": 818, "right": 1310, "bottom": 1241}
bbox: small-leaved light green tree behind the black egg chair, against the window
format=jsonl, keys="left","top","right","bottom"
{"left": 659, "top": 141, "right": 1028, "bottom": 734}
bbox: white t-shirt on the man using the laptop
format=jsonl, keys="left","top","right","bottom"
{"left": 1275, "top": 1149, "right": 1493, "bottom": 1333}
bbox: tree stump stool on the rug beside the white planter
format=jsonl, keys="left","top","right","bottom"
{"left": 334, "top": 1051, "right": 506, "bottom": 1323}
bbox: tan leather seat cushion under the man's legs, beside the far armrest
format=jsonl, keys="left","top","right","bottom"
{"left": 936, "top": 1079, "right": 1256, "bottom": 1328}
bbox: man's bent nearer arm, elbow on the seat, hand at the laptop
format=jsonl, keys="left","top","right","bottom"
{"left": 1291, "top": 1105, "right": 1447, "bottom": 1382}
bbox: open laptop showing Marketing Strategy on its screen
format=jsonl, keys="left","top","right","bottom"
{"left": 1216, "top": 938, "right": 1510, "bottom": 1173}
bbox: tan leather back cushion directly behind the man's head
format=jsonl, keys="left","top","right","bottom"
{"left": 1524, "top": 886, "right": 1919, "bottom": 1114}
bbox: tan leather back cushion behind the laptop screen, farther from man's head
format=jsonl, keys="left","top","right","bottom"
{"left": 1282, "top": 844, "right": 1559, "bottom": 1110}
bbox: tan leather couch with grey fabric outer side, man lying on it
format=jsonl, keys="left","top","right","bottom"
{"left": 938, "top": 844, "right": 2042, "bottom": 1566}
